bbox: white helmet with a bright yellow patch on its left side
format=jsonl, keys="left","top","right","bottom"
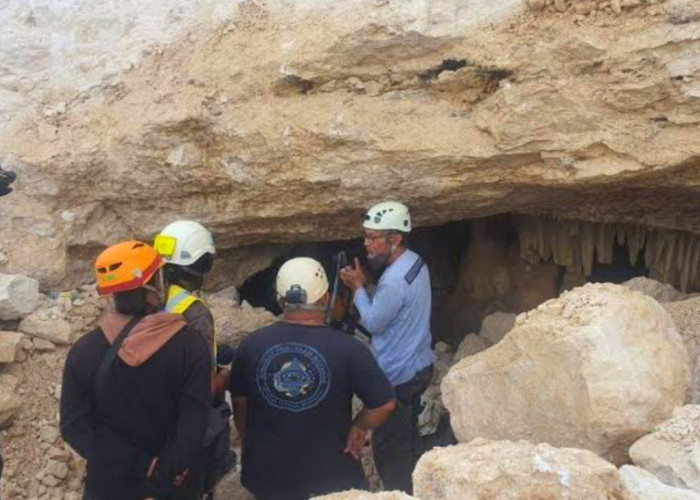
{"left": 153, "top": 220, "right": 216, "bottom": 266}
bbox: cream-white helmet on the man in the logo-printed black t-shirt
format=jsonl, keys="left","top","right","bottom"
{"left": 275, "top": 257, "right": 328, "bottom": 304}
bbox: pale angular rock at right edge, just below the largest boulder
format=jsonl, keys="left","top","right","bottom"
{"left": 630, "top": 405, "right": 700, "bottom": 493}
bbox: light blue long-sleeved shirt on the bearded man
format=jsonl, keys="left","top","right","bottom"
{"left": 354, "top": 249, "right": 433, "bottom": 386}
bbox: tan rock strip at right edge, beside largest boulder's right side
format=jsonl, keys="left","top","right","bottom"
{"left": 663, "top": 298, "right": 700, "bottom": 404}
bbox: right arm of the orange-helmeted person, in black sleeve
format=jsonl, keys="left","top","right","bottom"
{"left": 153, "top": 336, "right": 211, "bottom": 484}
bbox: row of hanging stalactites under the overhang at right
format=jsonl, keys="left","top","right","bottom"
{"left": 513, "top": 214, "right": 700, "bottom": 291}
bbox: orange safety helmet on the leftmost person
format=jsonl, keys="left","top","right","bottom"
{"left": 95, "top": 241, "right": 165, "bottom": 295}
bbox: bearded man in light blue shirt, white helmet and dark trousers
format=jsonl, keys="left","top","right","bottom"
{"left": 340, "top": 201, "right": 433, "bottom": 493}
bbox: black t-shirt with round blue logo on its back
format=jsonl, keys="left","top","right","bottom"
{"left": 231, "top": 323, "right": 394, "bottom": 500}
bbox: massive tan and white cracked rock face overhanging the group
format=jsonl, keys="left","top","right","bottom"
{"left": 0, "top": 0, "right": 700, "bottom": 287}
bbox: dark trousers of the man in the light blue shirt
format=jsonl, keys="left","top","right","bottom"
{"left": 372, "top": 365, "right": 433, "bottom": 494}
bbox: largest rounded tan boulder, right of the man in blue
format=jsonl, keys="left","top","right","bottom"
{"left": 442, "top": 284, "right": 690, "bottom": 464}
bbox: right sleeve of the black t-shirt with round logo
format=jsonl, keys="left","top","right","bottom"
{"left": 350, "top": 339, "right": 395, "bottom": 410}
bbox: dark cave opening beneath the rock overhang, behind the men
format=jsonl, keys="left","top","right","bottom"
{"left": 240, "top": 213, "right": 700, "bottom": 349}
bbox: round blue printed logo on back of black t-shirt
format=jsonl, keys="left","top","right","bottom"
{"left": 256, "top": 342, "right": 331, "bottom": 413}
